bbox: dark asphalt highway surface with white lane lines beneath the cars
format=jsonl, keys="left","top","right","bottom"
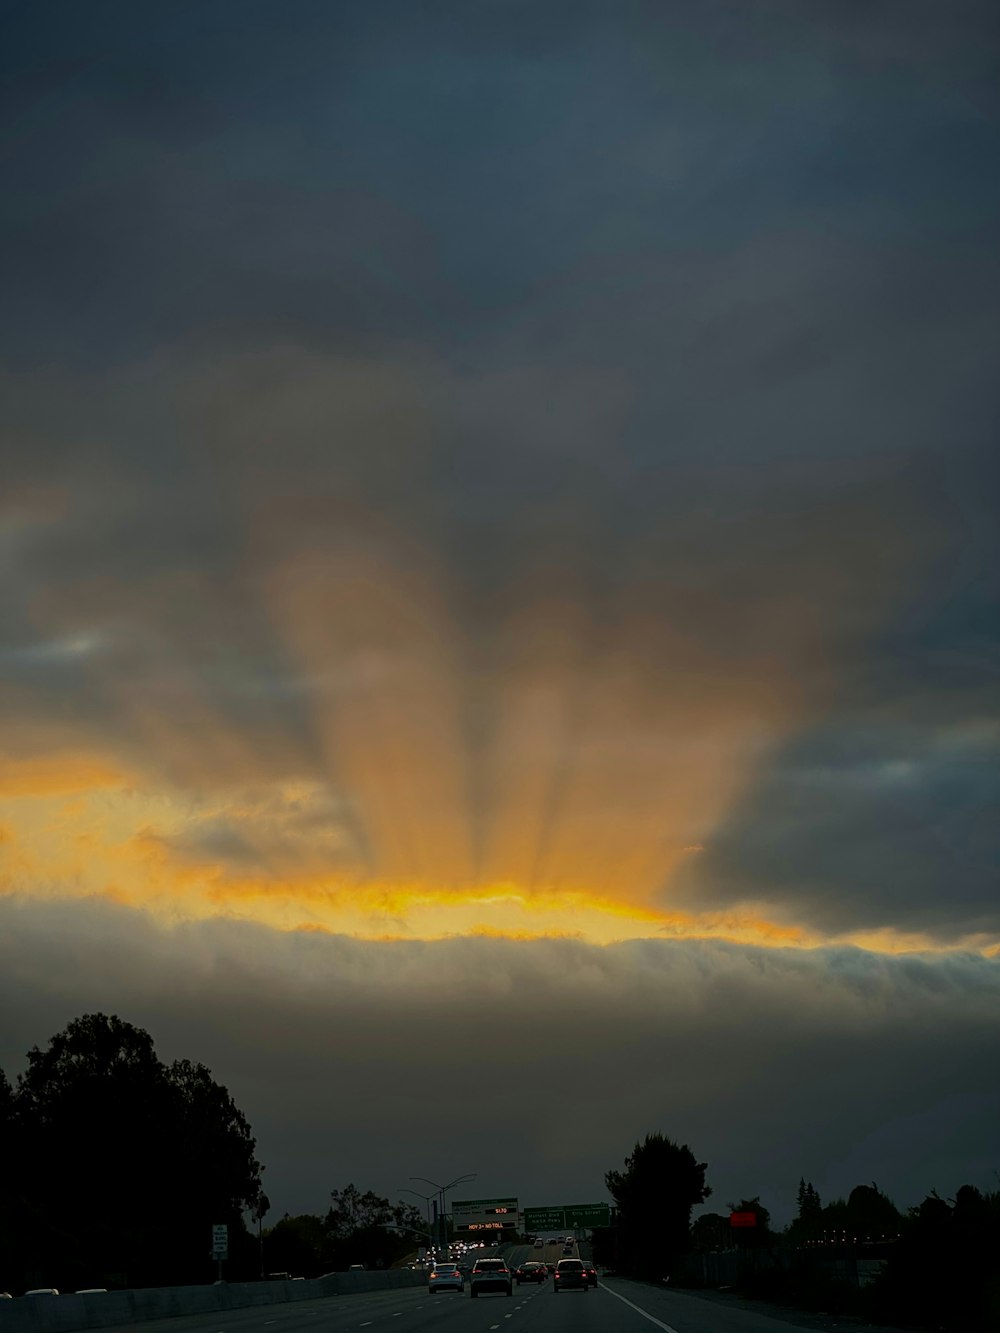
{"left": 96, "top": 1277, "right": 853, "bottom": 1333}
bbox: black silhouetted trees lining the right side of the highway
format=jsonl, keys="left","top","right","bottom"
{"left": 593, "top": 1133, "right": 1000, "bottom": 1333}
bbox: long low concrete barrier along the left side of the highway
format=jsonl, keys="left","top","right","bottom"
{"left": 0, "top": 1269, "right": 427, "bottom": 1333}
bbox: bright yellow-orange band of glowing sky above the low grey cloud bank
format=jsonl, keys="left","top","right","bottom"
{"left": 0, "top": 762, "right": 997, "bottom": 953}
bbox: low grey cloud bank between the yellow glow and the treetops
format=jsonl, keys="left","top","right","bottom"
{"left": 0, "top": 900, "right": 1000, "bottom": 1220}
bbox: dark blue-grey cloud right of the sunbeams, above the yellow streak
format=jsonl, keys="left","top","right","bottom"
{"left": 672, "top": 714, "right": 1000, "bottom": 938}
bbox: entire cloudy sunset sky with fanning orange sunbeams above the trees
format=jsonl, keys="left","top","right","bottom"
{"left": 0, "top": 0, "right": 1000, "bottom": 1222}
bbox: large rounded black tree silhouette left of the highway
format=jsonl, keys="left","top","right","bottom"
{"left": 0, "top": 1013, "right": 261, "bottom": 1292}
